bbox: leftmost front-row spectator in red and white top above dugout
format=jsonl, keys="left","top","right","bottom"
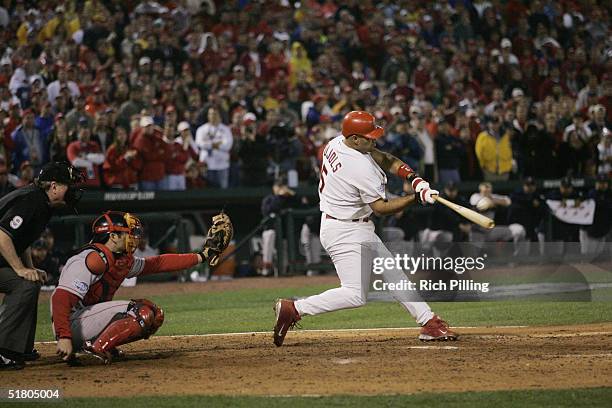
{"left": 66, "top": 119, "right": 104, "bottom": 187}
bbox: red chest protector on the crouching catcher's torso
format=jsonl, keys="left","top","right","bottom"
{"left": 82, "top": 244, "right": 134, "bottom": 306}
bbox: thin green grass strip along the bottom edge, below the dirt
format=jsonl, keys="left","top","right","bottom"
{"left": 19, "top": 388, "right": 612, "bottom": 408}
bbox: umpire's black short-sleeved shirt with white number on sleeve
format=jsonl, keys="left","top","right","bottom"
{"left": 0, "top": 184, "right": 53, "bottom": 267}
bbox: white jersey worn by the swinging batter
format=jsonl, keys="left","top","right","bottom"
{"left": 319, "top": 135, "right": 387, "bottom": 220}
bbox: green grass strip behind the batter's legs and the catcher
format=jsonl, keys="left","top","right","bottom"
{"left": 37, "top": 286, "right": 612, "bottom": 341}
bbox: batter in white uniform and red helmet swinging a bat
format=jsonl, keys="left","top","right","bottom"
{"left": 274, "top": 111, "right": 457, "bottom": 346}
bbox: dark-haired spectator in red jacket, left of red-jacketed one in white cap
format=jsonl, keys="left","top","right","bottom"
{"left": 102, "top": 127, "right": 143, "bottom": 190}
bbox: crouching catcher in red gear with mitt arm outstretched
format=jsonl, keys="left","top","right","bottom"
{"left": 51, "top": 211, "right": 233, "bottom": 364}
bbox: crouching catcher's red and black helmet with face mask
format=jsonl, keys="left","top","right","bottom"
{"left": 91, "top": 211, "right": 143, "bottom": 254}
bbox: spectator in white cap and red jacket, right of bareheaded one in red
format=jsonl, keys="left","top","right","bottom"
{"left": 133, "top": 116, "right": 169, "bottom": 191}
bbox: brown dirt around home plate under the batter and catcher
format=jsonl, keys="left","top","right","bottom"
{"left": 2, "top": 323, "right": 612, "bottom": 397}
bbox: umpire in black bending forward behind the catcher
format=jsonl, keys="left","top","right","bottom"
{"left": 0, "top": 162, "right": 83, "bottom": 370}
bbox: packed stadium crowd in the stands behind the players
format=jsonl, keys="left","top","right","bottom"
{"left": 0, "top": 0, "right": 612, "bottom": 193}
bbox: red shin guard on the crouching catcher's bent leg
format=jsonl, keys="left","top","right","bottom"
{"left": 83, "top": 299, "right": 164, "bottom": 364}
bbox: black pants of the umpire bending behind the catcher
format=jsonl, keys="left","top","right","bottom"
{"left": 0, "top": 267, "right": 40, "bottom": 354}
